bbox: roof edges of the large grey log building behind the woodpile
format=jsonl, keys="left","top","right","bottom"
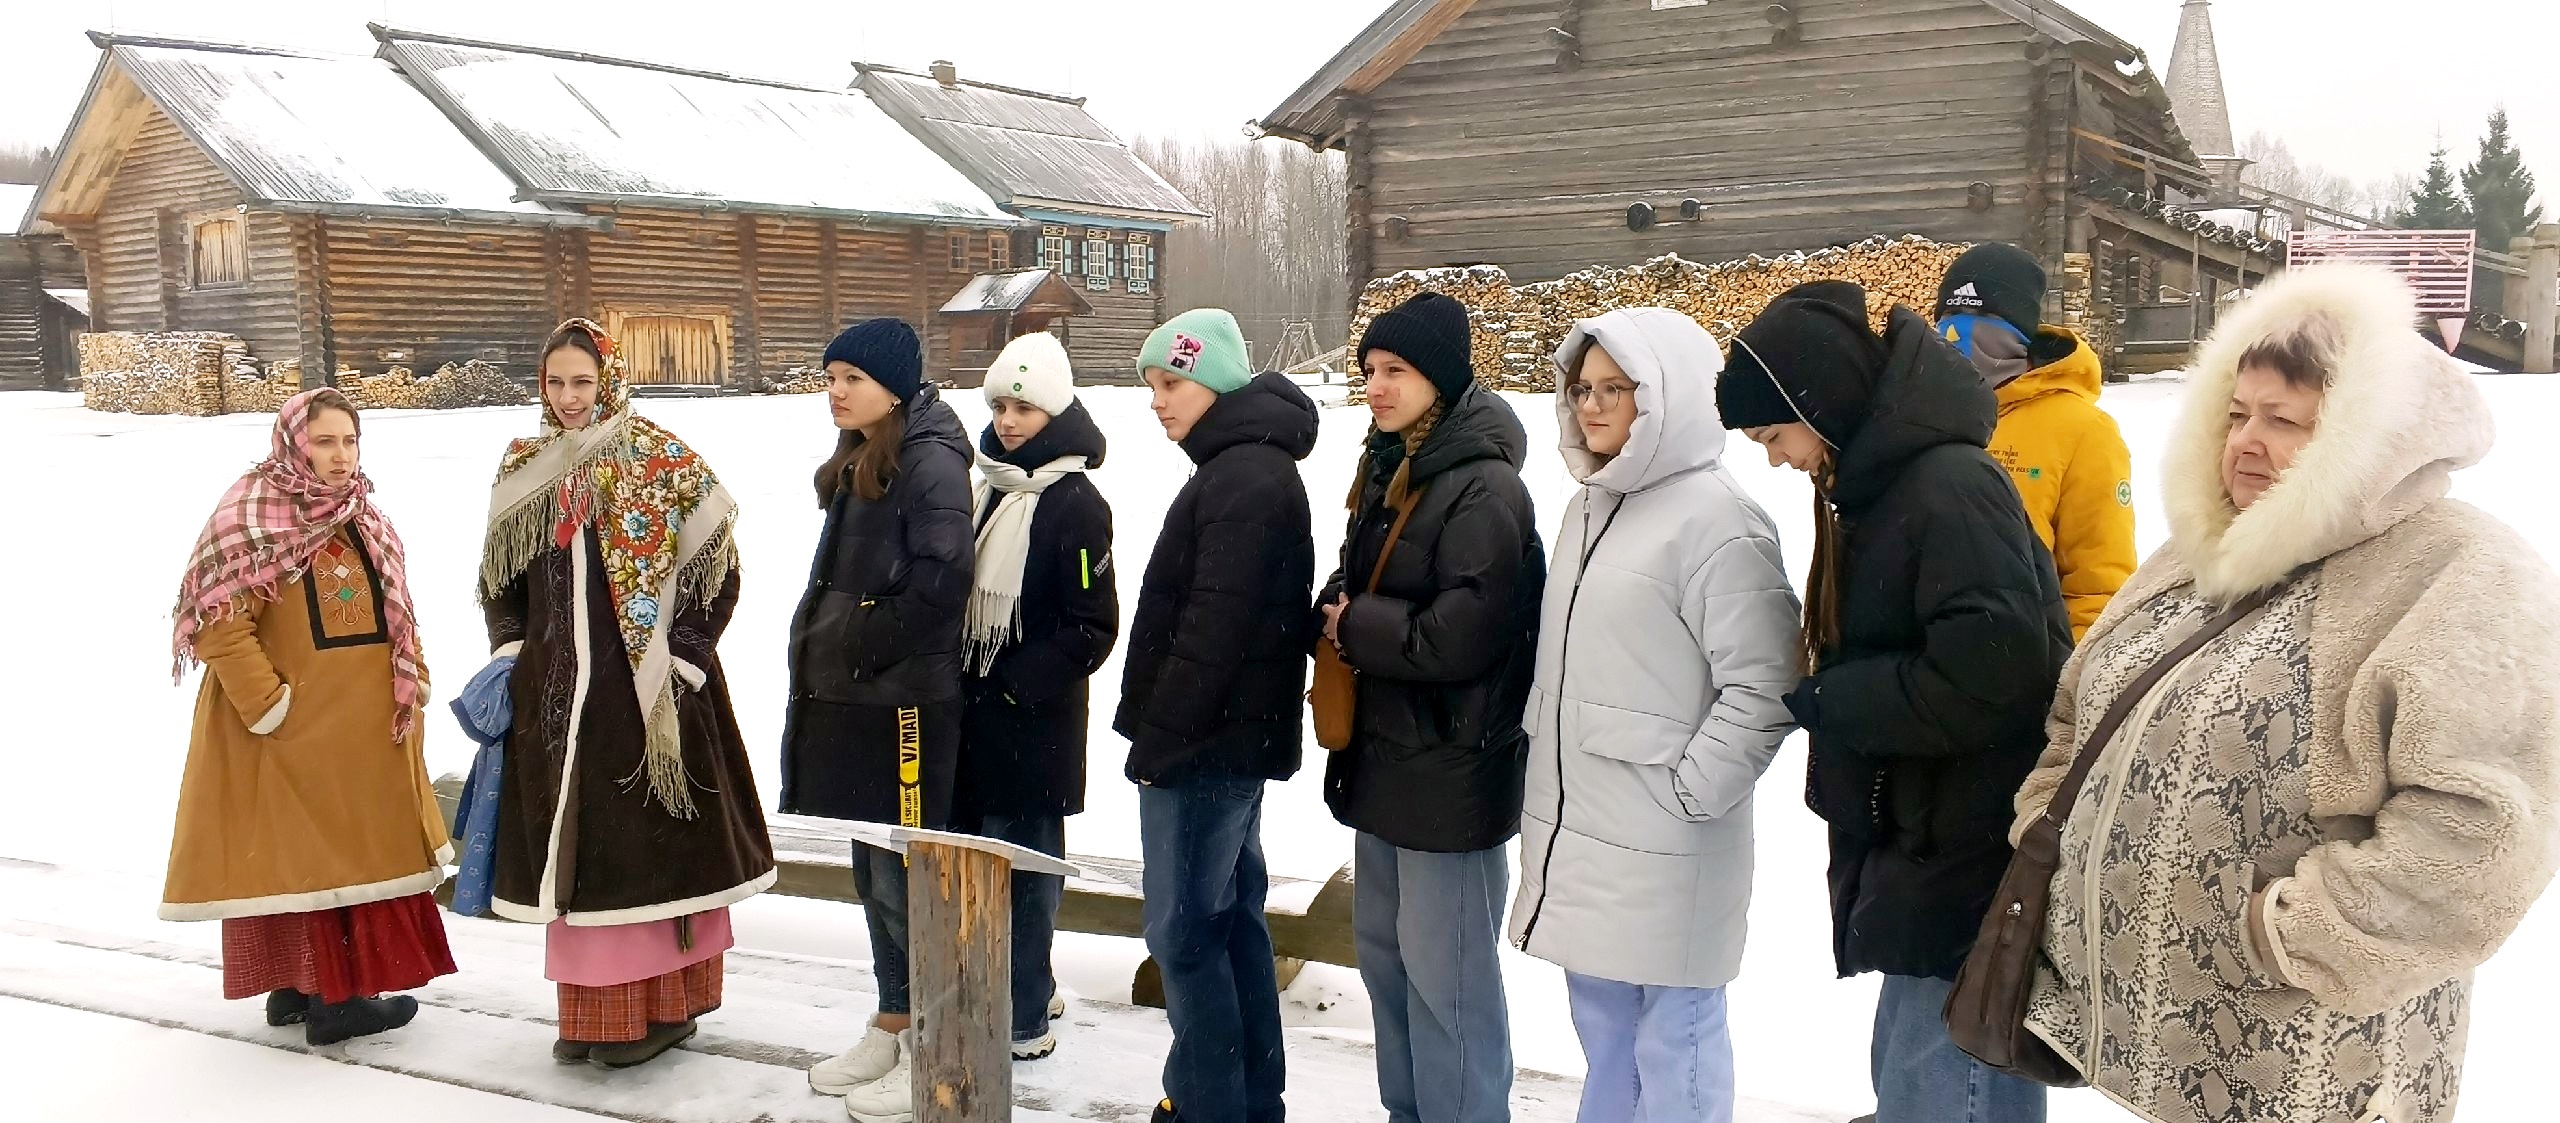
{"left": 1257, "top": 0, "right": 2143, "bottom": 148}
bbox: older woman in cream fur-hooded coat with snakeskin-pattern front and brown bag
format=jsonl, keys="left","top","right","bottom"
{"left": 2017, "top": 266, "right": 2560, "bottom": 1123}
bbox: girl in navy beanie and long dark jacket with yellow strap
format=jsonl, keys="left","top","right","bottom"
{"left": 783, "top": 320, "right": 973, "bottom": 1118}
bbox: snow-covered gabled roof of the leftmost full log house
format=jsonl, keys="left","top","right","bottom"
{"left": 33, "top": 33, "right": 591, "bottom": 225}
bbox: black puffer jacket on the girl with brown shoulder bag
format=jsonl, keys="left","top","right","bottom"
{"left": 1316, "top": 389, "right": 1546, "bottom": 852}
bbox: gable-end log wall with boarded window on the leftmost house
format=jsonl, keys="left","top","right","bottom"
{"left": 74, "top": 107, "right": 302, "bottom": 361}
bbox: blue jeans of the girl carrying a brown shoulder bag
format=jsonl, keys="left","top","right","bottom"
{"left": 1352, "top": 834, "right": 1510, "bottom": 1123}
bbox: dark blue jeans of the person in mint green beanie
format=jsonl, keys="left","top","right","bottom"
{"left": 1137, "top": 778, "right": 1288, "bottom": 1123}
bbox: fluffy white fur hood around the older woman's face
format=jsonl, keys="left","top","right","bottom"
{"left": 2163, "top": 263, "right": 2496, "bottom": 604}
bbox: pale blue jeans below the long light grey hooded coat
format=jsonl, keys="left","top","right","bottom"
{"left": 1564, "top": 972, "right": 1733, "bottom": 1123}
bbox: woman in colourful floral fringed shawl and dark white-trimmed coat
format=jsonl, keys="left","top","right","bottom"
{"left": 479, "top": 320, "right": 773, "bottom": 1067}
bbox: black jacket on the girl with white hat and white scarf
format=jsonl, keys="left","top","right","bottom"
{"left": 955, "top": 402, "right": 1119, "bottom": 821}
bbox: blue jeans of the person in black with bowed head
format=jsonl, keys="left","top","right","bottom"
{"left": 1871, "top": 975, "right": 2045, "bottom": 1123}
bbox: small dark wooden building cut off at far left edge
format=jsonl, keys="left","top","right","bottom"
{"left": 0, "top": 184, "right": 90, "bottom": 389}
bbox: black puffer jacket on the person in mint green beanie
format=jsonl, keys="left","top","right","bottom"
{"left": 1111, "top": 373, "right": 1316, "bottom": 785}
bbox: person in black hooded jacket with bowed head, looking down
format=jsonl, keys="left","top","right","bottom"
{"left": 1715, "top": 281, "right": 2071, "bottom": 1123}
